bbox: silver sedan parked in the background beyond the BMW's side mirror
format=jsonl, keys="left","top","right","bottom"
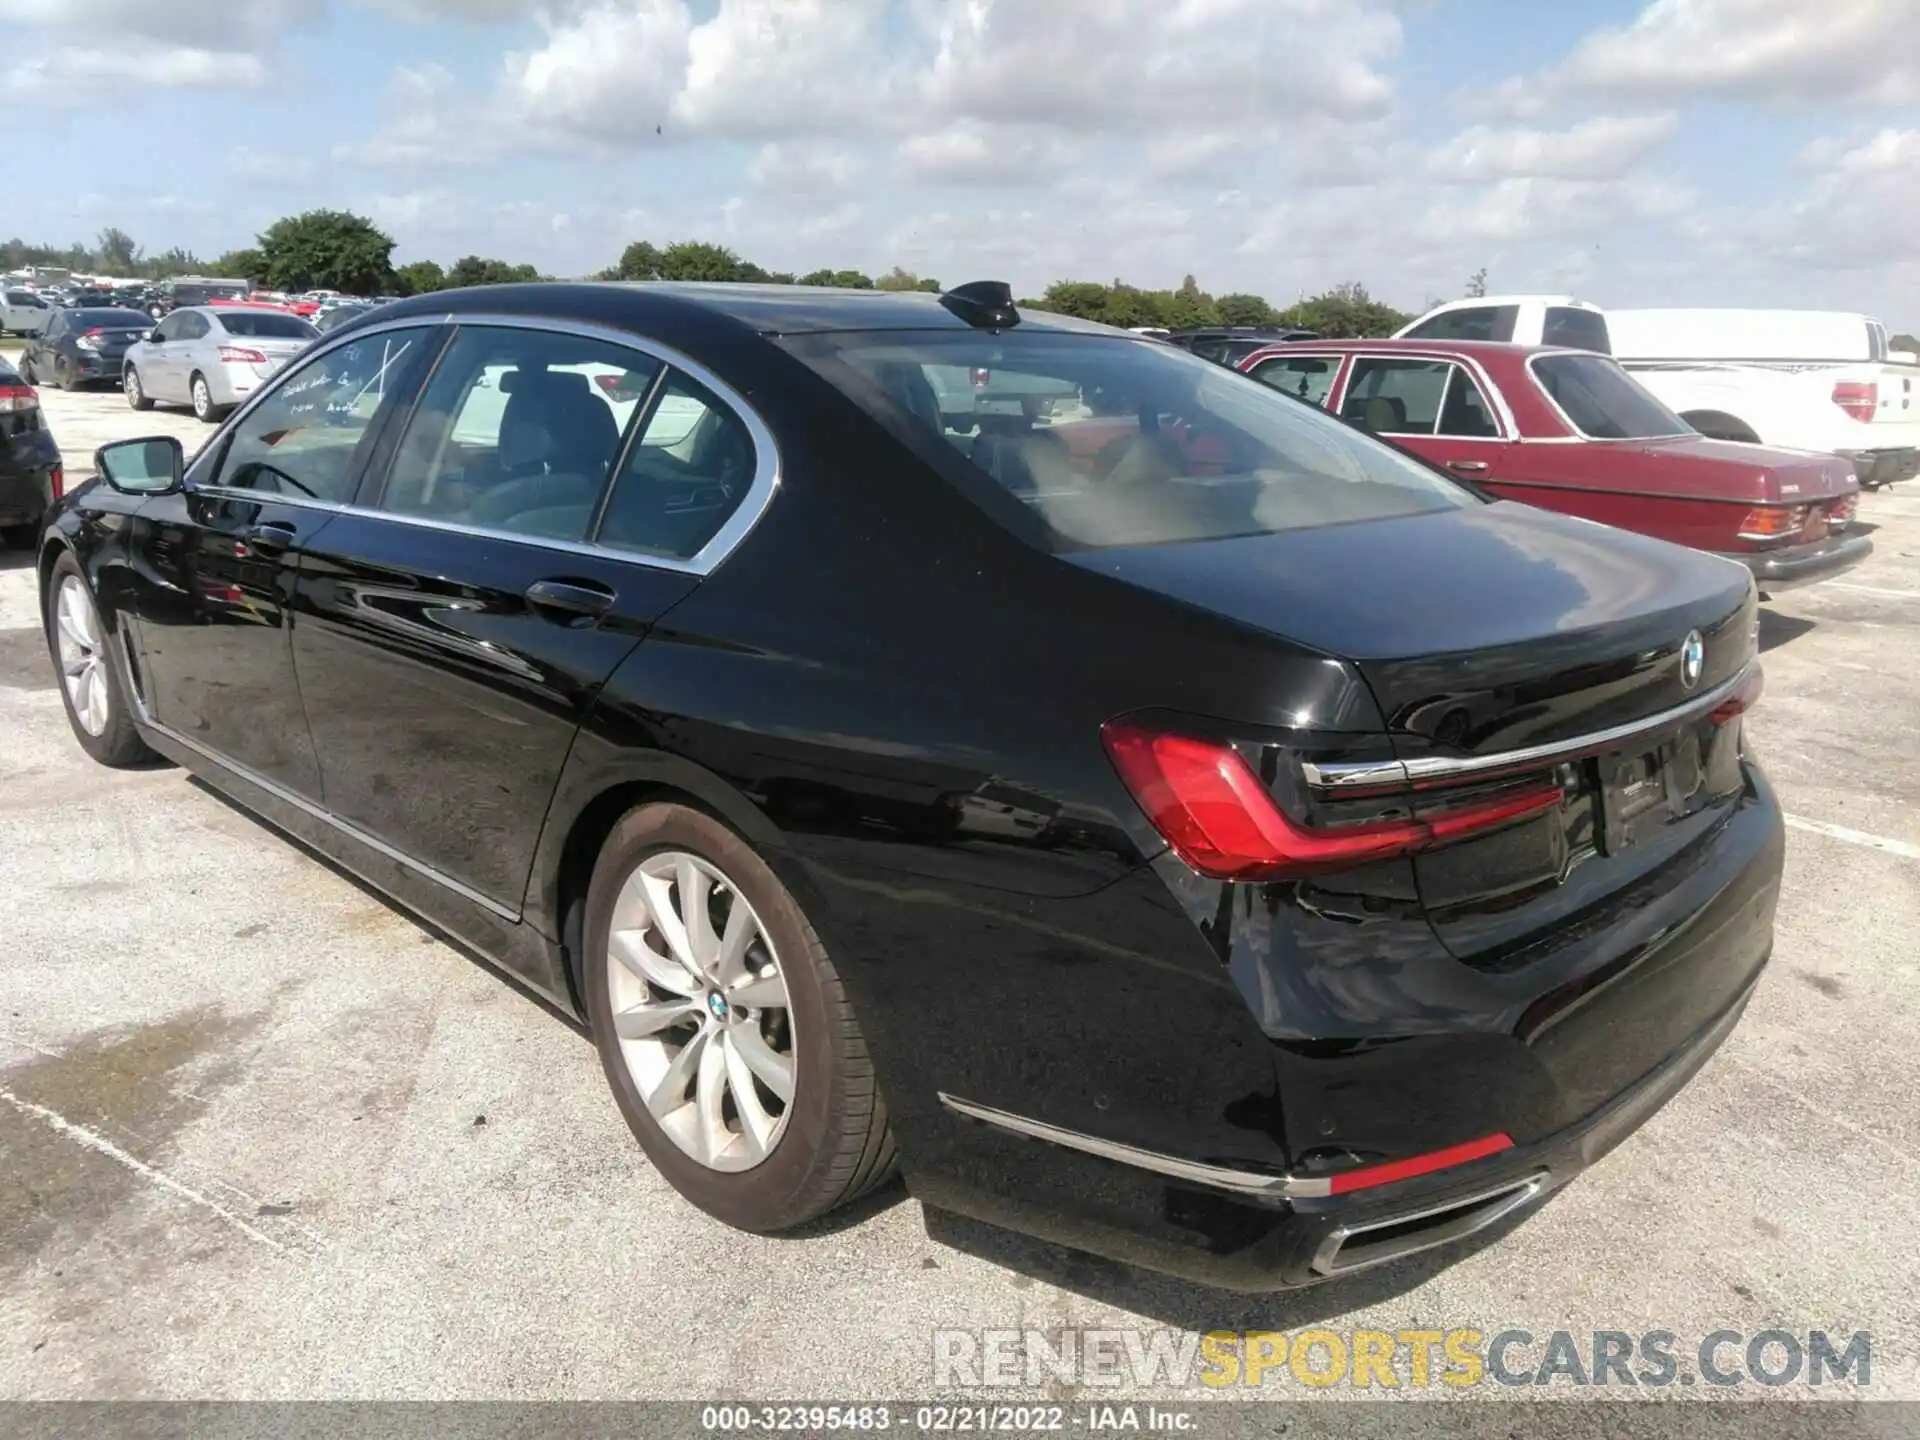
{"left": 121, "top": 305, "right": 319, "bottom": 424}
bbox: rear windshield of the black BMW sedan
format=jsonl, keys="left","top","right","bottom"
{"left": 783, "top": 330, "right": 1480, "bottom": 549}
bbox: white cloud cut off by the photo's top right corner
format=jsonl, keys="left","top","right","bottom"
{"left": 1532, "top": 0, "right": 1920, "bottom": 106}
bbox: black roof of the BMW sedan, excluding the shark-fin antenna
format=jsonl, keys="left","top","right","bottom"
{"left": 368, "top": 280, "right": 1140, "bottom": 342}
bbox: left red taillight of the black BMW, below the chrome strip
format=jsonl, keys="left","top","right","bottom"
{"left": 1100, "top": 722, "right": 1561, "bottom": 879}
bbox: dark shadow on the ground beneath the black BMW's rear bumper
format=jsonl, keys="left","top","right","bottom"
{"left": 925, "top": 1206, "right": 1538, "bottom": 1331}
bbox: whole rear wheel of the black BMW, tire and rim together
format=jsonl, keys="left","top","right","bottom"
{"left": 582, "top": 804, "right": 895, "bottom": 1235}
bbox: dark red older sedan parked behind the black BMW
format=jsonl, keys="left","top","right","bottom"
{"left": 1236, "top": 340, "right": 1872, "bottom": 591}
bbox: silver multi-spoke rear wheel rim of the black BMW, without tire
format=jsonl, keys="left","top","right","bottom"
{"left": 607, "top": 851, "right": 795, "bottom": 1171}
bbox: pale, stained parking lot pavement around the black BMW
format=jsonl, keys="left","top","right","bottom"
{"left": 0, "top": 390, "right": 1920, "bottom": 1432}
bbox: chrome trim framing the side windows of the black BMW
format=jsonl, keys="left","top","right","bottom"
{"left": 188, "top": 311, "right": 781, "bottom": 576}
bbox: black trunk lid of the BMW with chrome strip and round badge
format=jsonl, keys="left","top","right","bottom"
{"left": 1068, "top": 503, "right": 1757, "bottom": 972}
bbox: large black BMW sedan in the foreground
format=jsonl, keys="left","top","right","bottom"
{"left": 40, "top": 282, "right": 1784, "bottom": 1288}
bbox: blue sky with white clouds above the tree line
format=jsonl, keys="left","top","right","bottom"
{"left": 0, "top": 0, "right": 1920, "bottom": 328}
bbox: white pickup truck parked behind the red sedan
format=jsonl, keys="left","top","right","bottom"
{"left": 1400, "top": 296, "right": 1920, "bottom": 490}
